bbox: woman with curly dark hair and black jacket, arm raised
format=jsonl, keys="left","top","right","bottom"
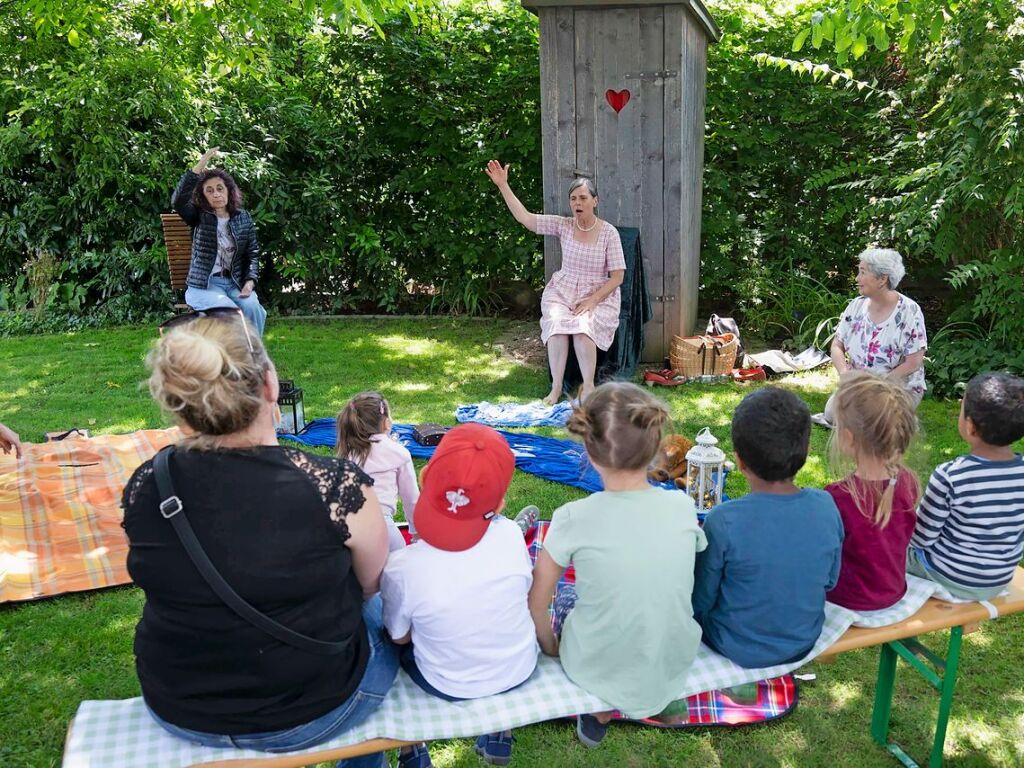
{"left": 171, "top": 146, "right": 266, "bottom": 336}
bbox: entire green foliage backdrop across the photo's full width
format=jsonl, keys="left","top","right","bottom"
{"left": 0, "top": 0, "right": 1024, "bottom": 392}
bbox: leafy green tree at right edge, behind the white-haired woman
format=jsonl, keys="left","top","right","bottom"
{"left": 794, "top": 0, "right": 1024, "bottom": 393}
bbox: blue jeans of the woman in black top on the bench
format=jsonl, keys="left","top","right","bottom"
{"left": 150, "top": 595, "right": 398, "bottom": 768}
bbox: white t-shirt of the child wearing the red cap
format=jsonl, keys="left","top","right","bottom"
{"left": 381, "top": 517, "right": 540, "bottom": 698}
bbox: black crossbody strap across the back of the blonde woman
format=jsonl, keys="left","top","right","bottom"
{"left": 153, "top": 445, "right": 349, "bottom": 656}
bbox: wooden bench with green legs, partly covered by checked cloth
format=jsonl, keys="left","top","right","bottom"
{"left": 69, "top": 568, "right": 1024, "bottom": 768}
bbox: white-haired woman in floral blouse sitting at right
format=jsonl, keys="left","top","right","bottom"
{"left": 811, "top": 248, "right": 928, "bottom": 428}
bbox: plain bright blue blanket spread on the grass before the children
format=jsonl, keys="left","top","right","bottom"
{"left": 278, "top": 419, "right": 726, "bottom": 501}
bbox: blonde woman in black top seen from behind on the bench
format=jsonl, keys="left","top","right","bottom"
{"left": 122, "top": 311, "right": 398, "bottom": 766}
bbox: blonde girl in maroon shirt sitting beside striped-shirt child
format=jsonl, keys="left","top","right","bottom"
{"left": 825, "top": 371, "right": 921, "bottom": 610}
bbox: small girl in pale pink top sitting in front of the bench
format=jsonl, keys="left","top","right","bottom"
{"left": 337, "top": 392, "right": 420, "bottom": 551}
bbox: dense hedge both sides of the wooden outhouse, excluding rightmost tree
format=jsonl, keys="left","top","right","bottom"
{"left": 0, "top": 3, "right": 868, "bottom": 327}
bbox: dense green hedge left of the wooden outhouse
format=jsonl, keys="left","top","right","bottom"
{"left": 0, "top": 3, "right": 543, "bottom": 318}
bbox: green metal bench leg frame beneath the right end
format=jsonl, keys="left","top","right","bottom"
{"left": 871, "top": 627, "right": 964, "bottom": 768}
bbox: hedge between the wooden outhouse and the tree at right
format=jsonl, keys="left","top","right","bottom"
{"left": 700, "top": 0, "right": 884, "bottom": 343}
